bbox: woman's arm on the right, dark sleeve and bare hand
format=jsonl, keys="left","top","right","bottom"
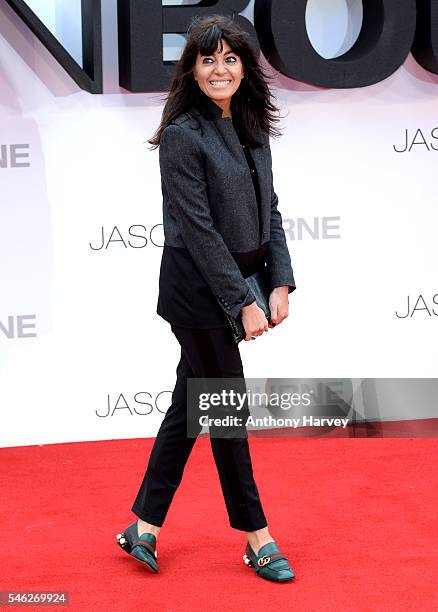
{"left": 267, "top": 140, "right": 296, "bottom": 325}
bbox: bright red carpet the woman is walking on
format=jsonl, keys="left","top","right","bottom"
{"left": 0, "top": 438, "right": 438, "bottom": 612}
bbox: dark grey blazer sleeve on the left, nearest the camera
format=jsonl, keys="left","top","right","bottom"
{"left": 159, "top": 124, "right": 255, "bottom": 317}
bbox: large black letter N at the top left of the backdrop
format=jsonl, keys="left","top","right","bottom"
{"left": 6, "top": 0, "right": 102, "bottom": 93}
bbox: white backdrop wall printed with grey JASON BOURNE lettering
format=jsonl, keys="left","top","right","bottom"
{"left": 0, "top": 0, "right": 438, "bottom": 446}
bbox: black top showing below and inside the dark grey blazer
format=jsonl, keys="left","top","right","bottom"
{"left": 157, "top": 106, "right": 269, "bottom": 329}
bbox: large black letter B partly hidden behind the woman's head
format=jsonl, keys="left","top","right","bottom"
{"left": 118, "top": 0, "right": 259, "bottom": 92}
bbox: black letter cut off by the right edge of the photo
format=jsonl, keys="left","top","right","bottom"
{"left": 412, "top": 0, "right": 438, "bottom": 74}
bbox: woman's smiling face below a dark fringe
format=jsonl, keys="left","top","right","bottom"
{"left": 193, "top": 40, "right": 245, "bottom": 116}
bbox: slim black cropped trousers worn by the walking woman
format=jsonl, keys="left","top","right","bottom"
{"left": 132, "top": 325, "right": 267, "bottom": 531}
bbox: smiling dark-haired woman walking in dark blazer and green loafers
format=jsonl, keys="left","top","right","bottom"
{"left": 117, "top": 15, "right": 295, "bottom": 582}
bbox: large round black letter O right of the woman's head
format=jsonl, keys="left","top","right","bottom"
{"left": 254, "top": 0, "right": 416, "bottom": 89}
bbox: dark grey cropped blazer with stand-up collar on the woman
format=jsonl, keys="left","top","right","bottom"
{"left": 159, "top": 96, "right": 295, "bottom": 317}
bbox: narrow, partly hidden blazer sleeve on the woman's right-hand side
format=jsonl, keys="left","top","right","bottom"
{"left": 267, "top": 140, "right": 296, "bottom": 293}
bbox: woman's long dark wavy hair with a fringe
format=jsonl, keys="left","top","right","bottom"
{"left": 147, "top": 15, "right": 281, "bottom": 149}
